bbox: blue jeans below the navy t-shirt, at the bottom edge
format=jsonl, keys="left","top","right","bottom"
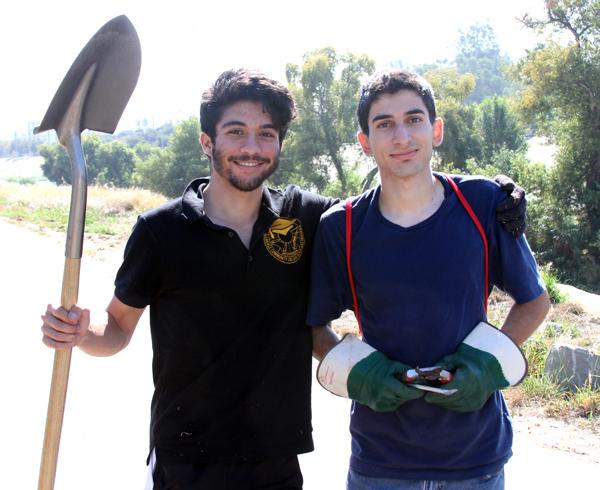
{"left": 346, "top": 469, "right": 504, "bottom": 490}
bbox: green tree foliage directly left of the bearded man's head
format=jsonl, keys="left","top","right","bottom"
{"left": 134, "top": 117, "right": 210, "bottom": 197}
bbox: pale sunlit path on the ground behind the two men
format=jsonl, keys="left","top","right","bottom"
{"left": 0, "top": 219, "right": 600, "bottom": 490}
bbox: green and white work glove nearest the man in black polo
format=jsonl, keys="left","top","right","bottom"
{"left": 317, "top": 335, "right": 424, "bottom": 412}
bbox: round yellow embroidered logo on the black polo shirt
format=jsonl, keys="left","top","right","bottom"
{"left": 263, "top": 218, "right": 304, "bottom": 264}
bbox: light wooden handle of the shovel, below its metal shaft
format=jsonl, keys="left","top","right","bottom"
{"left": 38, "top": 258, "right": 81, "bottom": 490}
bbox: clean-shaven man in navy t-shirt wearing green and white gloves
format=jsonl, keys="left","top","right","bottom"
{"left": 307, "top": 70, "right": 549, "bottom": 490}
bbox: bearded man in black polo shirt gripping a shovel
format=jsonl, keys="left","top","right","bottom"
{"left": 42, "top": 70, "right": 523, "bottom": 490}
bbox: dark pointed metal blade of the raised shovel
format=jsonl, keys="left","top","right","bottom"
{"left": 34, "top": 15, "right": 142, "bottom": 134}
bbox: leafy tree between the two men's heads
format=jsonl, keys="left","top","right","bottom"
{"left": 282, "top": 48, "right": 375, "bottom": 195}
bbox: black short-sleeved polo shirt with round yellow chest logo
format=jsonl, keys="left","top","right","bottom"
{"left": 115, "top": 179, "right": 335, "bottom": 461}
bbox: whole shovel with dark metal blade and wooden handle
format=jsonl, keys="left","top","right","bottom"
{"left": 34, "top": 16, "right": 141, "bottom": 490}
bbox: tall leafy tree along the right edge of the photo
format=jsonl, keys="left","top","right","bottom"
{"left": 516, "top": 0, "right": 600, "bottom": 288}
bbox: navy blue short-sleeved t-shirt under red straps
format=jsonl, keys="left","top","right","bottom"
{"left": 307, "top": 175, "right": 544, "bottom": 480}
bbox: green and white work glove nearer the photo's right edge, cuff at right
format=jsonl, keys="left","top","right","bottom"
{"left": 425, "top": 322, "right": 527, "bottom": 412}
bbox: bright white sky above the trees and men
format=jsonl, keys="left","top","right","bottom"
{"left": 0, "top": 0, "right": 544, "bottom": 140}
